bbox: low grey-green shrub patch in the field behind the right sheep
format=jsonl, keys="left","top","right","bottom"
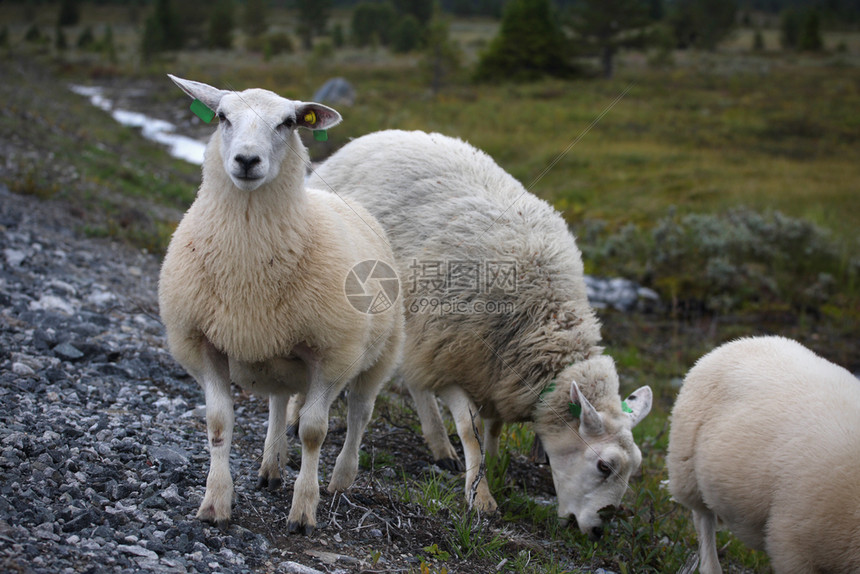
{"left": 579, "top": 209, "right": 860, "bottom": 313}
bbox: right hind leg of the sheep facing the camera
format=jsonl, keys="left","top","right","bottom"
{"left": 328, "top": 357, "right": 391, "bottom": 492}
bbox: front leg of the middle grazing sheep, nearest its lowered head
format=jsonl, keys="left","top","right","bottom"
{"left": 439, "top": 386, "right": 498, "bottom": 512}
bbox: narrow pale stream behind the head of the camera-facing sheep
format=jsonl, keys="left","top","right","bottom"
{"left": 69, "top": 84, "right": 206, "bottom": 165}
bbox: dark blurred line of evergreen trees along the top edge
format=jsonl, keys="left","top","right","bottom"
{"left": 6, "top": 0, "right": 848, "bottom": 85}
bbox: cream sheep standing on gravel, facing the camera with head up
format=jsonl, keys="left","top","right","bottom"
{"left": 159, "top": 76, "right": 403, "bottom": 534}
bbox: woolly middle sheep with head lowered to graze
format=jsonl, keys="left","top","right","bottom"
{"left": 311, "top": 131, "right": 652, "bottom": 537}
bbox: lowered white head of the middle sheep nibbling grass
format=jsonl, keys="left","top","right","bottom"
{"left": 536, "top": 376, "right": 652, "bottom": 540}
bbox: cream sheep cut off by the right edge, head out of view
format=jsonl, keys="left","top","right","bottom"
{"left": 667, "top": 337, "right": 860, "bottom": 574}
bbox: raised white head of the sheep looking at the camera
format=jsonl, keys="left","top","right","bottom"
{"left": 168, "top": 74, "right": 341, "bottom": 191}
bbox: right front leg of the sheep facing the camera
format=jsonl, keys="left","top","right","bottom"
{"left": 287, "top": 358, "right": 330, "bottom": 536}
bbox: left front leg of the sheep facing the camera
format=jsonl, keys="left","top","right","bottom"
{"left": 196, "top": 341, "right": 233, "bottom": 530}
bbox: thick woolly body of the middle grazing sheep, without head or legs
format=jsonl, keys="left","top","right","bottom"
{"left": 311, "top": 131, "right": 600, "bottom": 418}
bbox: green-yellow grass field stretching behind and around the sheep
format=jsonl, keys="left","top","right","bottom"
{"left": 0, "top": 3, "right": 860, "bottom": 573}
